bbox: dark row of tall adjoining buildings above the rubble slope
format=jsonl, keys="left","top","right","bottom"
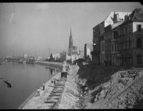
{"left": 91, "top": 8, "right": 143, "bottom": 66}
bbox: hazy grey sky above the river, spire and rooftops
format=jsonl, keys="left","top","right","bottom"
{"left": 0, "top": 2, "right": 143, "bottom": 57}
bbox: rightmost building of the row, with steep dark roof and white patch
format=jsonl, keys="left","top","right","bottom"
{"left": 118, "top": 8, "right": 143, "bottom": 66}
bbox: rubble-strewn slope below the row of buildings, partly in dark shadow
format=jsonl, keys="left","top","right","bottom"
{"left": 77, "top": 64, "right": 143, "bottom": 109}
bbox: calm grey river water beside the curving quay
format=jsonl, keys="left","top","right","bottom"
{"left": 0, "top": 62, "right": 58, "bottom": 109}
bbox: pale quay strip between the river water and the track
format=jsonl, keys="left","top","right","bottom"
{"left": 18, "top": 73, "right": 61, "bottom": 109}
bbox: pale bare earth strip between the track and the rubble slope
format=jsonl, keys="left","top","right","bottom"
{"left": 57, "top": 65, "right": 81, "bottom": 109}
